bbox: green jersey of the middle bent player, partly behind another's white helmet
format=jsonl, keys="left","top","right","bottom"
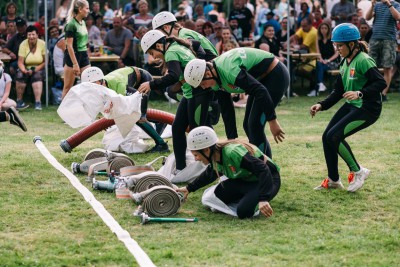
{"left": 165, "top": 42, "right": 196, "bottom": 99}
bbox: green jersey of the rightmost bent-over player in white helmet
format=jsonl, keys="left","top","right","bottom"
{"left": 212, "top": 47, "right": 275, "bottom": 93}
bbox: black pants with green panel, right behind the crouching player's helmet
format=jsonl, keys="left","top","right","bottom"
{"left": 172, "top": 88, "right": 213, "bottom": 170}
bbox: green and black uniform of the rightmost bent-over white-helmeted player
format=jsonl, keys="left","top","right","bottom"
{"left": 212, "top": 48, "right": 289, "bottom": 157}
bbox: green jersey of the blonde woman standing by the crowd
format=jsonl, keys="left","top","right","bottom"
{"left": 64, "top": 18, "right": 89, "bottom": 52}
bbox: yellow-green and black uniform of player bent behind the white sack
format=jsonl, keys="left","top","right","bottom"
{"left": 104, "top": 67, "right": 166, "bottom": 145}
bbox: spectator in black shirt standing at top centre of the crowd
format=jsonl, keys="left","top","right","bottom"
{"left": 228, "top": 0, "right": 254, "bottom": 38}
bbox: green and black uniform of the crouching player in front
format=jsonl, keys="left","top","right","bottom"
{"left": 187, "top": 143, "right": 281, "bottom": 218}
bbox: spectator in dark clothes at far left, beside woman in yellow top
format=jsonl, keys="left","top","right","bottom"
{"left": 3, "top": 17, "right": 26, "bottom": 76}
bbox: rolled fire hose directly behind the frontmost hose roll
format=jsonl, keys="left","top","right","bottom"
{"left": 126, "top": 171, "right": 173, "bottom": 193}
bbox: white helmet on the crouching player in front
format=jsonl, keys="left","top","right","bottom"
{"left": 187, "top": 126, "right": 218, "bottom": 150}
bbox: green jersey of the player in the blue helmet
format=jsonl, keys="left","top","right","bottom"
{"left": 340, "top": 52, "right": 376, "bottom": 108}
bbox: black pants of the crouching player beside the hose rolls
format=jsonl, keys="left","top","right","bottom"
{"left": 214, "top": 172, "right": 281, "bottom": 219}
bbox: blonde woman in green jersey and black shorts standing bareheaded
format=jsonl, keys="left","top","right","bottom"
{"left": 62, "top": 0, "right": 90, "bottom": 98}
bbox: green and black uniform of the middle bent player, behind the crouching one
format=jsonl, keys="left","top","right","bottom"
{"left": 150, "top": 42, "right": 237, "bottom": 170}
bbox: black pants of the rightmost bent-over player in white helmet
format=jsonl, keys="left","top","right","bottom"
{"left": 243, "top": 62, "right": 290, "bottom": 158}
